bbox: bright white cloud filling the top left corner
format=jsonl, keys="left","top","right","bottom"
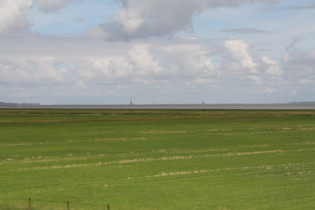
{"left": 0, "top": 0, "right": 33, "bottom": 37}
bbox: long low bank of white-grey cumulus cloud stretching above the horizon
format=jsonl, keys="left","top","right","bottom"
{"left": 0, "top": 37, "right": 315, "bottom": 103}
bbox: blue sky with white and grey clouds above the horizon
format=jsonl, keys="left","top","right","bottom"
{"left": 0, "top": 0, "right": 315, "bottom": 105}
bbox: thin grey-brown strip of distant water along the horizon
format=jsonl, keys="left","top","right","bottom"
{"left": 0, "top": 103, "right": 315, "bottom": 110}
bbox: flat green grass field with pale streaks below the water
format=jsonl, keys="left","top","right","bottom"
{"left": 0, "top": 109, "right": 315, "bottom": 210}
